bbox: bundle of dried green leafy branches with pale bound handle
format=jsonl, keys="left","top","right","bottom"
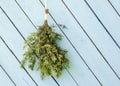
{"left": 21, "top": 0, "right": 69, "bottom": 79}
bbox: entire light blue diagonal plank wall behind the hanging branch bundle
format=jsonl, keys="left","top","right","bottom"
{"left": 0, "top": 0, "right": 120, "bottom": 86}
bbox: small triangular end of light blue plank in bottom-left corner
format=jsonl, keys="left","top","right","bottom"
{"left": 0, "top": 65, "right": 16, "bottom": 86}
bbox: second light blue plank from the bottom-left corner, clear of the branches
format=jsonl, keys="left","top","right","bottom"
{"left": 0, "top": 39, "right": 36, "bottom": 86}
